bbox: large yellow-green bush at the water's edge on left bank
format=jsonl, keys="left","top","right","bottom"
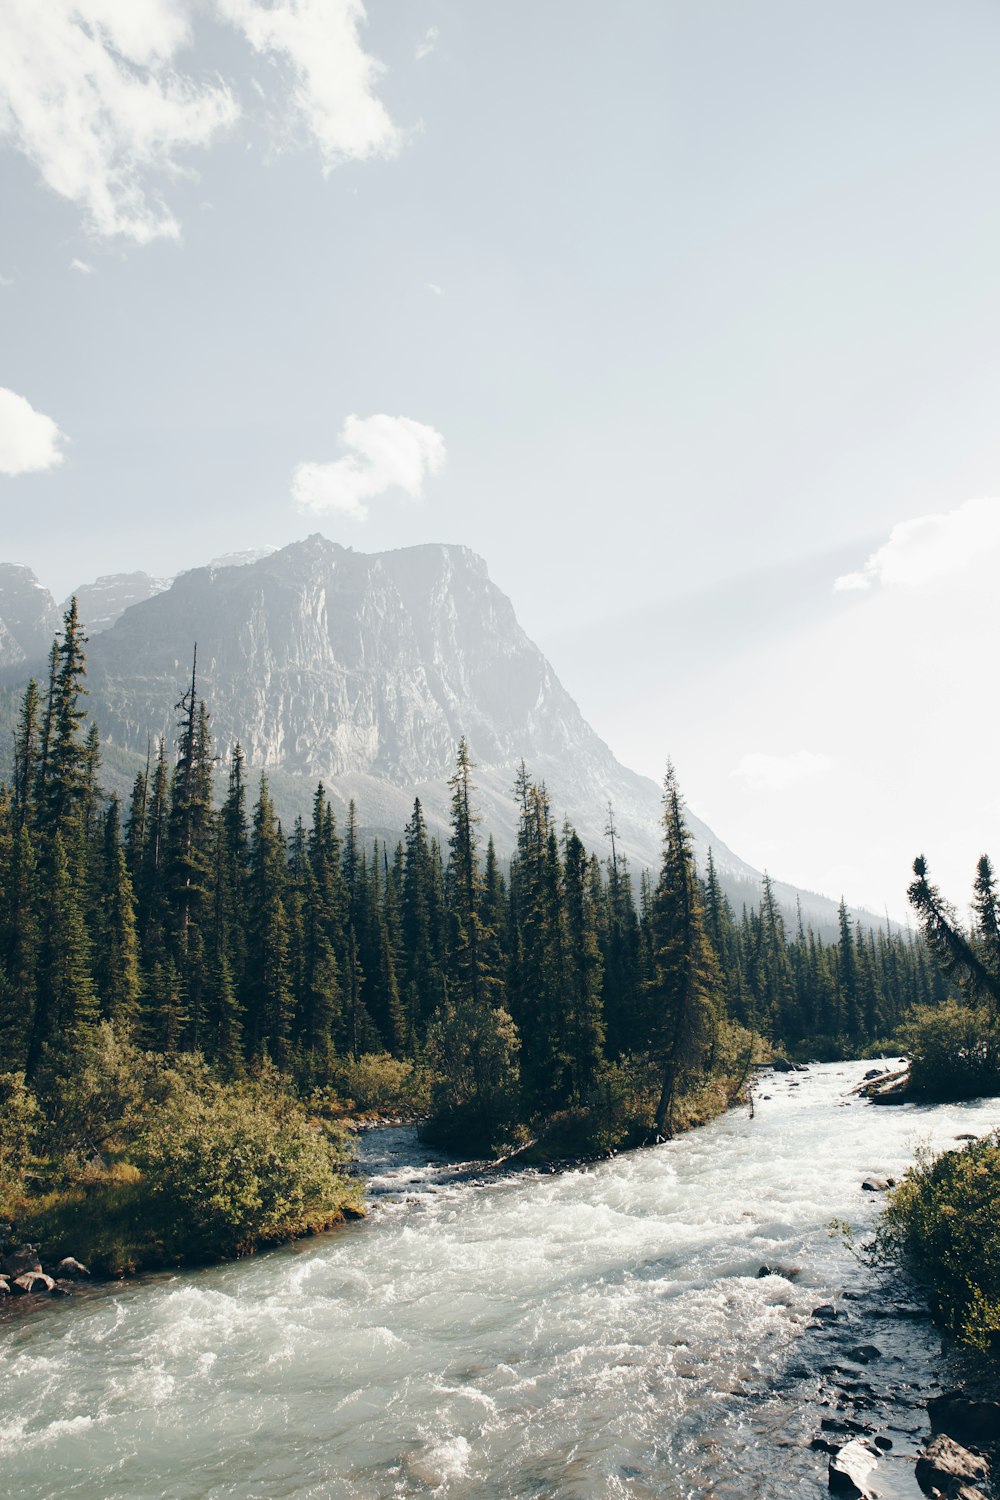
{"left": 12, "top": 1025, "right": 358, "bottom": 1275}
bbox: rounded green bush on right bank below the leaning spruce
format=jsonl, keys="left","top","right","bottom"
{"left": 900, "top": 1001, "right": 1000, "bottom": 1100}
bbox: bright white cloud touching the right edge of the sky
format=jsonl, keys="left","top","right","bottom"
{"left": 834, "top": 497, "right": 1000, "bottom": 591}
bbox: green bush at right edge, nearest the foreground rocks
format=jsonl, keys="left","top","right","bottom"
{"left": 874, "top": 1130, "right": 1000, "bottom": 1361}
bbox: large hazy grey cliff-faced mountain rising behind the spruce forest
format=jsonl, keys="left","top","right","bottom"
{"left": 64, "top": 536, "right": 851, "bottom": 926}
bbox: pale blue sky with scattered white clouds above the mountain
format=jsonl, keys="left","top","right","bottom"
{"left": 0, "top": 0, "right": 1000, "bottom": 918}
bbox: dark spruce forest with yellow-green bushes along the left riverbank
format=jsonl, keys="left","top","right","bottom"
{"left": 0, "top": 605, "right": 946, "bottom": 1265}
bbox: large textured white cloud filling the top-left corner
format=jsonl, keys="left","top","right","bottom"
{"left": 0, "top": 0, "right": 238, "bottom": 245}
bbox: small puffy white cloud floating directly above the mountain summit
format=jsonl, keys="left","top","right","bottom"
{"left": 292, "top": 413, "right": 445, "bottom": 521}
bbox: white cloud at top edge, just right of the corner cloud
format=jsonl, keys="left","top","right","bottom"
{"left": 217, "top": 0, "right": 402, "bottom": 171}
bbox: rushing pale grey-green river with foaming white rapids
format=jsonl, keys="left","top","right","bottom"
{"left": 0, "top": 1064, "right": 1000, "bottom": 1500}
